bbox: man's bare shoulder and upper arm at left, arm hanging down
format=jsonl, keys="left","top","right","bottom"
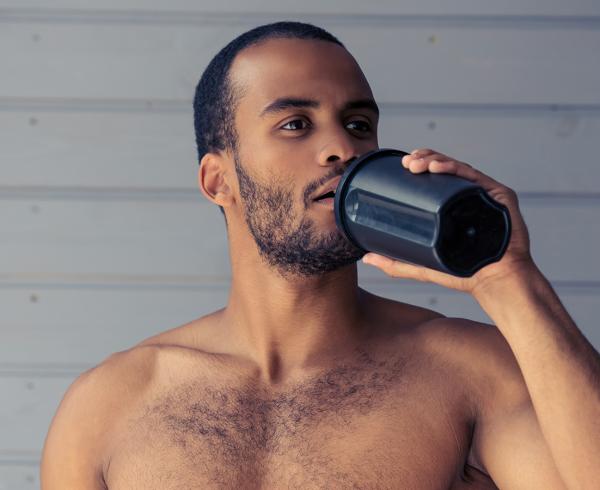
{"left": 41, "top": 346, "right": 158, "bottom": 489}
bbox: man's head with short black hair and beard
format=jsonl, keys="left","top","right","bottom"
{"left": 194, "top": 22, "right": 378, "bottom": 275}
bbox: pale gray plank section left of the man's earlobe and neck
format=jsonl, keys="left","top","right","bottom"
{"left": 0, "top": 195, "right": 229, "bottom": 281}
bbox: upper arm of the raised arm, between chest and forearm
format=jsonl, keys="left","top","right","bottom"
{"left": 472, "top": 320, "right": 566, "bottom": 490}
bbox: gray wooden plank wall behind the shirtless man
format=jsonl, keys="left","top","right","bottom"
{"left": 0, "top": 0, "right": 600, "bottom": 490}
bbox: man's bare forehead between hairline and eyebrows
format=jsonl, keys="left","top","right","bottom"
{"left": 230, "top": 39, "right": 372, "bottom": 115}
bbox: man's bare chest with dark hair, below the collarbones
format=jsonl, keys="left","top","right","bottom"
{"left": 107, "top": 352, "right": 493, "bottom": 490}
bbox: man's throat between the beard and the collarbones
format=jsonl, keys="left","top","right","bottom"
{"left": 223, "top": 284, "right": 373, "bottom": 382}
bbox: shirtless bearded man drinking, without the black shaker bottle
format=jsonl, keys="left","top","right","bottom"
{"left": 42, "top": 23, "right": 600, "bottom": 490}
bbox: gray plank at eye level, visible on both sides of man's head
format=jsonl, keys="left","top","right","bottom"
{"left": 0, "top": 106, "right": 600, "bottom": 193}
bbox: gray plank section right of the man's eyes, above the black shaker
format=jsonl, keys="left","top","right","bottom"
{"left": 379, "top": 111, "right": 600, "bottom": 194}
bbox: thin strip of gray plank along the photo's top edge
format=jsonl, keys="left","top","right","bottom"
{"left": 0, "top": 0, "right": 600, "bottom": 16}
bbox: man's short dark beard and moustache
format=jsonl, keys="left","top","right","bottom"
{"left": 234, "top": 152, "right": 366, "bottom": 277}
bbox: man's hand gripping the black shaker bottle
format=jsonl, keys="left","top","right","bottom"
{"left": 363, "top": 148, "right": 533, "bottom": 294}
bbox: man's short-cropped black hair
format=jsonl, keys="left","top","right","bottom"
{"left": 194, "top": 21, "right": 345, "bottom": 214}
